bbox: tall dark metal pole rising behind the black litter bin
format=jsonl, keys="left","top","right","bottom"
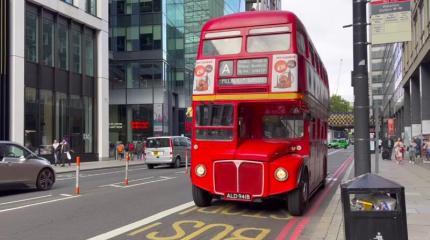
{"left": 351, "top": 0, "right": 371, "bottom": 176}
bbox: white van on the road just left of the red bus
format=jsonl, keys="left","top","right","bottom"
{"left": 145, "top": 136, "right": 191, "bottom": 169}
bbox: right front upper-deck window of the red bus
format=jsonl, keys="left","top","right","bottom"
{"left": 247, "top": 33, "right": 291, "bottom": 53}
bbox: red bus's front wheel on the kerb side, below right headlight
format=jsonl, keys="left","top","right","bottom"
{"left": 288, "top": 172, "right": 309, "bottom": 216}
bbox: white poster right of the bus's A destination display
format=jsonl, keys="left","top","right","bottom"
{"left": 271, "top": 54, "right": 298, "bottom": 92}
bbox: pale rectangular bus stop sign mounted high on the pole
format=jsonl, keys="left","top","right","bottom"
{"left": 370, "top": 0, "right": 412, "bottom": 45}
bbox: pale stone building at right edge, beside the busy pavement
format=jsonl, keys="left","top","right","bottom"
{"left": 383, "top": 0, "right": 430, "bottom": 146}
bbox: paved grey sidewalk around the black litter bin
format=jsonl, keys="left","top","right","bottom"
{"left": 308, "top": 155, "right": 430, "bottom": 240}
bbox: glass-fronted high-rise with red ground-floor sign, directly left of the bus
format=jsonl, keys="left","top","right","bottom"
{"left": 109, "top": 0, "right": 185, "bottom": 144}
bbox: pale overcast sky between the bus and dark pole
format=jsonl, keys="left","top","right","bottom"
{"left": 282, "top": 0, "right": 354, "bottom": 102}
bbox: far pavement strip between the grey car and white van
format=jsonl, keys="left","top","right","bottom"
{"left": 52, "top": 159, "right": 145, "bottom": 173}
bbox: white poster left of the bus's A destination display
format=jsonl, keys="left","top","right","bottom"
{"left": 193, "top": 59, "right": 215, "bottom": 95}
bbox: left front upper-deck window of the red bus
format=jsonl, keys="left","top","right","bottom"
{"left": 203, "top": 37, "right": 242, "bottom": 57}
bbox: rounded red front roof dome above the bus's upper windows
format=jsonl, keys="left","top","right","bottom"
{"left": 203, "top": 11, "right": 298, "bottom": 31}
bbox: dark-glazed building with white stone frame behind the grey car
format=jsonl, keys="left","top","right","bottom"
{"left": 7, "top": 0, "right": 109, "bottom": 160}
